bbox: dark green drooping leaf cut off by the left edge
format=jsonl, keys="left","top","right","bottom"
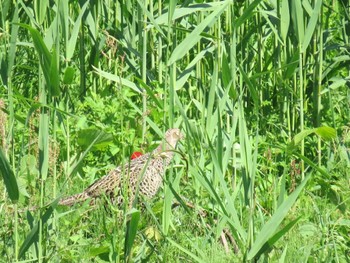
{"left": 0, "top": 148, "right": 19, "bottom": 203}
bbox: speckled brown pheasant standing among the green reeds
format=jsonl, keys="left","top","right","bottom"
{"left": 58, "top": 128, "right": 183, "bottom": 207}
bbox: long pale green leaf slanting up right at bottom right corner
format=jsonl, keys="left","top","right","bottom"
{"left": 247, "top": 174, "right": 311, "bottom": 260}
